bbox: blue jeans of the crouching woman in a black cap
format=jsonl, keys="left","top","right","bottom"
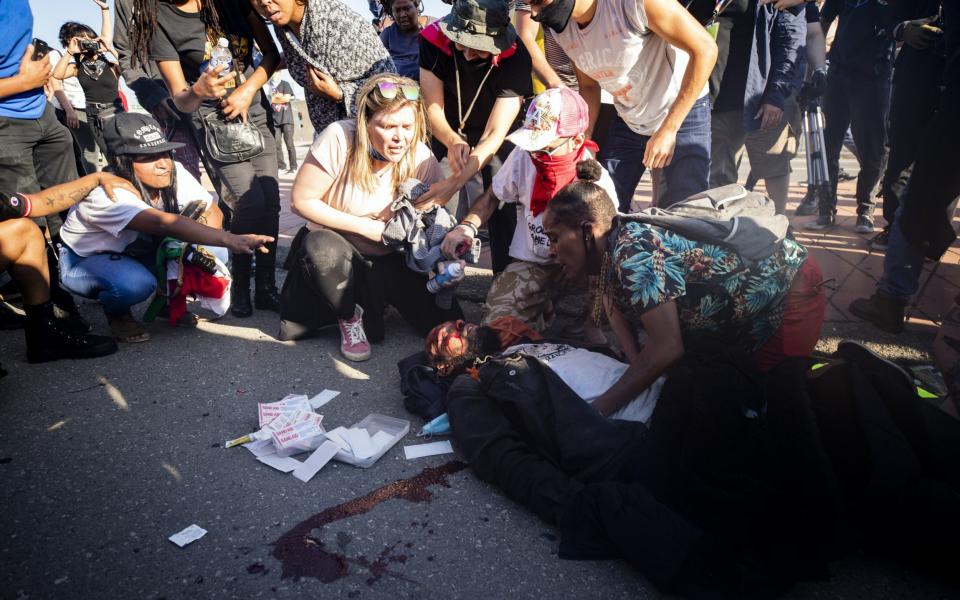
{"left": 60, "top": 245, "right": 157, "bottom": 316}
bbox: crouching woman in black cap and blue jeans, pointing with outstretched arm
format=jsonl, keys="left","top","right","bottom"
{"left": 60, "top": 113, "right": 273, "bottom": 342}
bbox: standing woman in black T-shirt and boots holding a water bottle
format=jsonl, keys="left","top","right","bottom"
{"left": 127, "top": 0, "right": 282, "bottom": 318}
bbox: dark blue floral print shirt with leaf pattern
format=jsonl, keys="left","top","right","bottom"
{"left": 608, "top": 220, "right": 807, "bottom": 352}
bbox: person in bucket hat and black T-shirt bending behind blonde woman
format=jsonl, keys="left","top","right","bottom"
{"left": 420, "top": 0, "right": 533, "bottom": 272}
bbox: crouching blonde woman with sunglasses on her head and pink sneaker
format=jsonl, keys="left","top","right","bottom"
{"left": 280, "top": 73, "right": 463, "bottom": 360}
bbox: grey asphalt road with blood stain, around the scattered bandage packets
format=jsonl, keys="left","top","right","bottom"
{"left": 0, "top": 282, "right": 957, "bottom": 599}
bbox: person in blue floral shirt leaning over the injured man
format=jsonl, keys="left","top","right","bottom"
{"left": 544, "top": 161, "right": 826, "bottom": 414}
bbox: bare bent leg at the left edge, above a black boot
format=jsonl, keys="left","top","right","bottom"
{"left": 0, "top": 219, "right": 50, "bottom": 306}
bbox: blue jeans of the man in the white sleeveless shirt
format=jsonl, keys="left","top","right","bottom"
{"left": 599, "top": 96, "right": 711, "bottom": 212}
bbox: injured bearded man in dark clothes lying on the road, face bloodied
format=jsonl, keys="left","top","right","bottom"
{"left": 426, "top": 321, "right": 960, "bottom": 596}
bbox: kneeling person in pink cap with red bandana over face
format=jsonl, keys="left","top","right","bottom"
{"left": 442, "top": 88, "right": 616, "bottom": 338}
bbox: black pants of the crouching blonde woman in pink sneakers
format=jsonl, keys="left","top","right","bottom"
{"left": 280, "top": 228, "right": 463, "bottom": 342}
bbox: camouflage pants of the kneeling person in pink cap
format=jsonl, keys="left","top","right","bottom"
{"left": 481, "top": 260, "right": 573, "bottom": 331}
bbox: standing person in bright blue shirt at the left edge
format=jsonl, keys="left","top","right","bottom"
{"left": 0, "top": 0, "right": 82, "bottom": 322}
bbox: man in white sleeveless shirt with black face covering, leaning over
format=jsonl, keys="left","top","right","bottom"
{"left": 530, "top": 0, "right": 717, "bottom": 212}
